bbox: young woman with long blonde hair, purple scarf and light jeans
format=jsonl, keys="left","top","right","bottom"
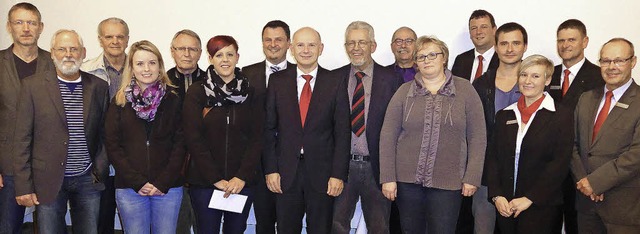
{"left": 105, "top": 41, "right": 185, "bottom": 233}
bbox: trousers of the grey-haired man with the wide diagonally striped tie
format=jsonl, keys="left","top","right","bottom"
{"left": 331, "top": 160, "right": 391, "bottom": 234}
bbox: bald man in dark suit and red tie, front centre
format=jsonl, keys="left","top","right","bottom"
{"left": 263, "top": 27, "right": 351, "bottom": 234}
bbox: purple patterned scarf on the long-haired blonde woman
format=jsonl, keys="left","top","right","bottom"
{"left": 124, "top": 78, "right": 166, "bottom": 122}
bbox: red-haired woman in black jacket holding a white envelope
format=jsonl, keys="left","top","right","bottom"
{"left": 183, "top": 36, "right": 264, "bottom": 233}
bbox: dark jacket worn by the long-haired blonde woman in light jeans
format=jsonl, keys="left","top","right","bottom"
{"left": 105, "top": 87, "right": 186, "bottom": 193}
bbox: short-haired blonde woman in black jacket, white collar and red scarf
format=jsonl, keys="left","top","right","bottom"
{"left": 487, "top": 55, "right": 573, "bottom": 234}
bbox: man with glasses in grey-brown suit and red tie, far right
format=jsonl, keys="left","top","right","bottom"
{"left": 571, "top": 38, "right": 640, "bottom": 233}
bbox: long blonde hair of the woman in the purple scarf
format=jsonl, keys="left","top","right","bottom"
{"left": 115, "top": 40, "right": 175, "bottom": 107}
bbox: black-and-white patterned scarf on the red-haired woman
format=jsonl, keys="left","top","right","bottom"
{"left": 204, "top": 65, "right": 249, "bottom": 107}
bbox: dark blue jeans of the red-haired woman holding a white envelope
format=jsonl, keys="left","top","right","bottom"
{"left": 189, "top": 186, "right": 253, "bottom": 234}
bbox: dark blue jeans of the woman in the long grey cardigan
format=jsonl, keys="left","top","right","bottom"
{"left": 396, "top": 182, "right": 462, "bottom": 234}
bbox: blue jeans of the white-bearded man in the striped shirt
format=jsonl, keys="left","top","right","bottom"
{"left": 36, "top": 172, "right": 102, "bottom": 234}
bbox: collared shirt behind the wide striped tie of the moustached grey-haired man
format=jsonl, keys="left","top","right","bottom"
{"left": 347, "top": 63, "right": 373, "bottom": 155}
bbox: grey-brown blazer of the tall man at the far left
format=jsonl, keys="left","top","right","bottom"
{"left": 0, "top": 45, "right": 53, "bottom": 176}
